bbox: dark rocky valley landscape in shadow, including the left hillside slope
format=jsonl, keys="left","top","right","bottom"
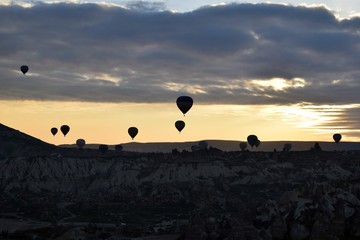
{"left": 0, "top": 125, "right": 360, "bottom": 240}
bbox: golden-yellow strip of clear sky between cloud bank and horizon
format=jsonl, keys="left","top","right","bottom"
{"left": 0, "top": 101, "right": 358, "bottom": 145}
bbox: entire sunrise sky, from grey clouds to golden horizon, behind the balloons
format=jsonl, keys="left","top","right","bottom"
{"left": 0, "top": 0, "right": 360, "bottom": 144}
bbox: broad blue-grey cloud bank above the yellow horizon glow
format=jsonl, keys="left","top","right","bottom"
{"left": 0, "top": 1, "right": 360, "bottom": 104}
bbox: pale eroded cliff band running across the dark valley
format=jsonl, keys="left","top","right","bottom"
{"left": 0, "top": 151, "right": 359, "bottom": 194}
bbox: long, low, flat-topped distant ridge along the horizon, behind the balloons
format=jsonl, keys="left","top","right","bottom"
{"left": 60, "top": 140, "right": 360, "bottom": 152}
